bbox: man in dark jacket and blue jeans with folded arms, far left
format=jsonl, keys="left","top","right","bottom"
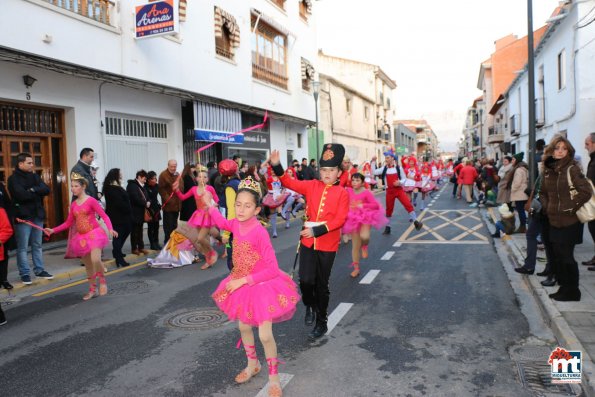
{"left": 8, "top": 153, "right": 54, "bottom": 285}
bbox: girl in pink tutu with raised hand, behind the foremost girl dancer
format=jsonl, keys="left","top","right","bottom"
{"left": 172, "top": 168, "right": 219, "bottom": 270}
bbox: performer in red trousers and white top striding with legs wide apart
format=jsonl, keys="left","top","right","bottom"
{"left": 371, "top": 150, "right": 423, "bottom": 234}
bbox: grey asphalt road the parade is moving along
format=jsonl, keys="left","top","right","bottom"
{"left": 0, "top": 186, "right": 548, "bottom": 396}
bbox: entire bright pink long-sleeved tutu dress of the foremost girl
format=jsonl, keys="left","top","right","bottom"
{"left": 209, "top": 207, "right": 300, "bottom": 326}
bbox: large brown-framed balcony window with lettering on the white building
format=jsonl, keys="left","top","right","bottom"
{"left": 251, "top": 14, "right": 288, "bottom": 89}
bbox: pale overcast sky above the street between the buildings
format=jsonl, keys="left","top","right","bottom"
{"left": 315, "top": 0, "right": 558, "bottom": 151}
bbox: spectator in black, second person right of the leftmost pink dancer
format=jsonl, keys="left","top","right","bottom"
{"left": 126, "top": 170, "right": 151, "bottom": 255}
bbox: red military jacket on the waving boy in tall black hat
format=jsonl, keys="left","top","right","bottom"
{"left": 279, "top": 173, "right": 349, "bottom": 252}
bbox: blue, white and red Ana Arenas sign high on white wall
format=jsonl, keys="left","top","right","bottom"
{"left": 136, "top": 0, "right": 178, "bottom": 39}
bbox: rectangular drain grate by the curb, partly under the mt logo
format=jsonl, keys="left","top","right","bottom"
{"left": 517, "top": 361, "right": 578, "bottom": 396}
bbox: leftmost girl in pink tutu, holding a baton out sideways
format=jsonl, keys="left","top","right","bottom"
{"left": 45, "top": 173, "right": 118, "bottom": 300}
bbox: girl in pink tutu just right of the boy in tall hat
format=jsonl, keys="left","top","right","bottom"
{"left": 342, "top": 172, "right": 388, "bottom": 277}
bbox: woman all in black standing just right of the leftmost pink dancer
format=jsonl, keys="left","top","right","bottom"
{"left": 103, "top": 168, "right": 132, "bottom": 267}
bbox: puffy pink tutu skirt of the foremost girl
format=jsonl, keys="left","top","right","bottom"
{"left": 213, "top": 271, "right": 300, "bottom": 327}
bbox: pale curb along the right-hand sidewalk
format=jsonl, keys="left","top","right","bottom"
{"left": 486, "top": 208, "right": 595, "bottom": 397}
